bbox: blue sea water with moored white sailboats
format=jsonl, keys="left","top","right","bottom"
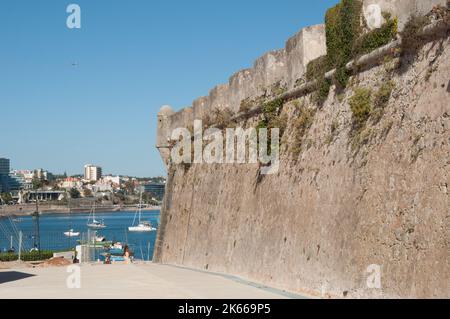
{"left": 0, "top": 211, "right": 160, "bottom": 260}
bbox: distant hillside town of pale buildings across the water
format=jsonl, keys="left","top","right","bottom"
{"left": 0, "top": 158, "right": 166, "bottom": 206}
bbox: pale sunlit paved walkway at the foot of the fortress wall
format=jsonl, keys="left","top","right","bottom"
{"left": 0, "top": 263, "right": 300, "bottom": 299}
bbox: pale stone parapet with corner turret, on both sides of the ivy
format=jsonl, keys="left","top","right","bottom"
{"left": 157, "top": 0, "right": 447, "bottom": 163}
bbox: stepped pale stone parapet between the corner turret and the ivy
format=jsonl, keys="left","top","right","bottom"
{"left": 158, "top": 25, "right": 326, "bottom": 127}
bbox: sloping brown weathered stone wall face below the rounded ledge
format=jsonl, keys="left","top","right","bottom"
{"left": 155, "top": 39, "right": 450, "bottom": 298}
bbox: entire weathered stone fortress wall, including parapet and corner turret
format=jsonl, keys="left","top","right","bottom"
{"left": 153, "top": 0, "right": 450, "bottom": 298}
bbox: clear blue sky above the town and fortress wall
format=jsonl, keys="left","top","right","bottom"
{"left": 0, "top": 0, "right": 338, "bottom": 176}
